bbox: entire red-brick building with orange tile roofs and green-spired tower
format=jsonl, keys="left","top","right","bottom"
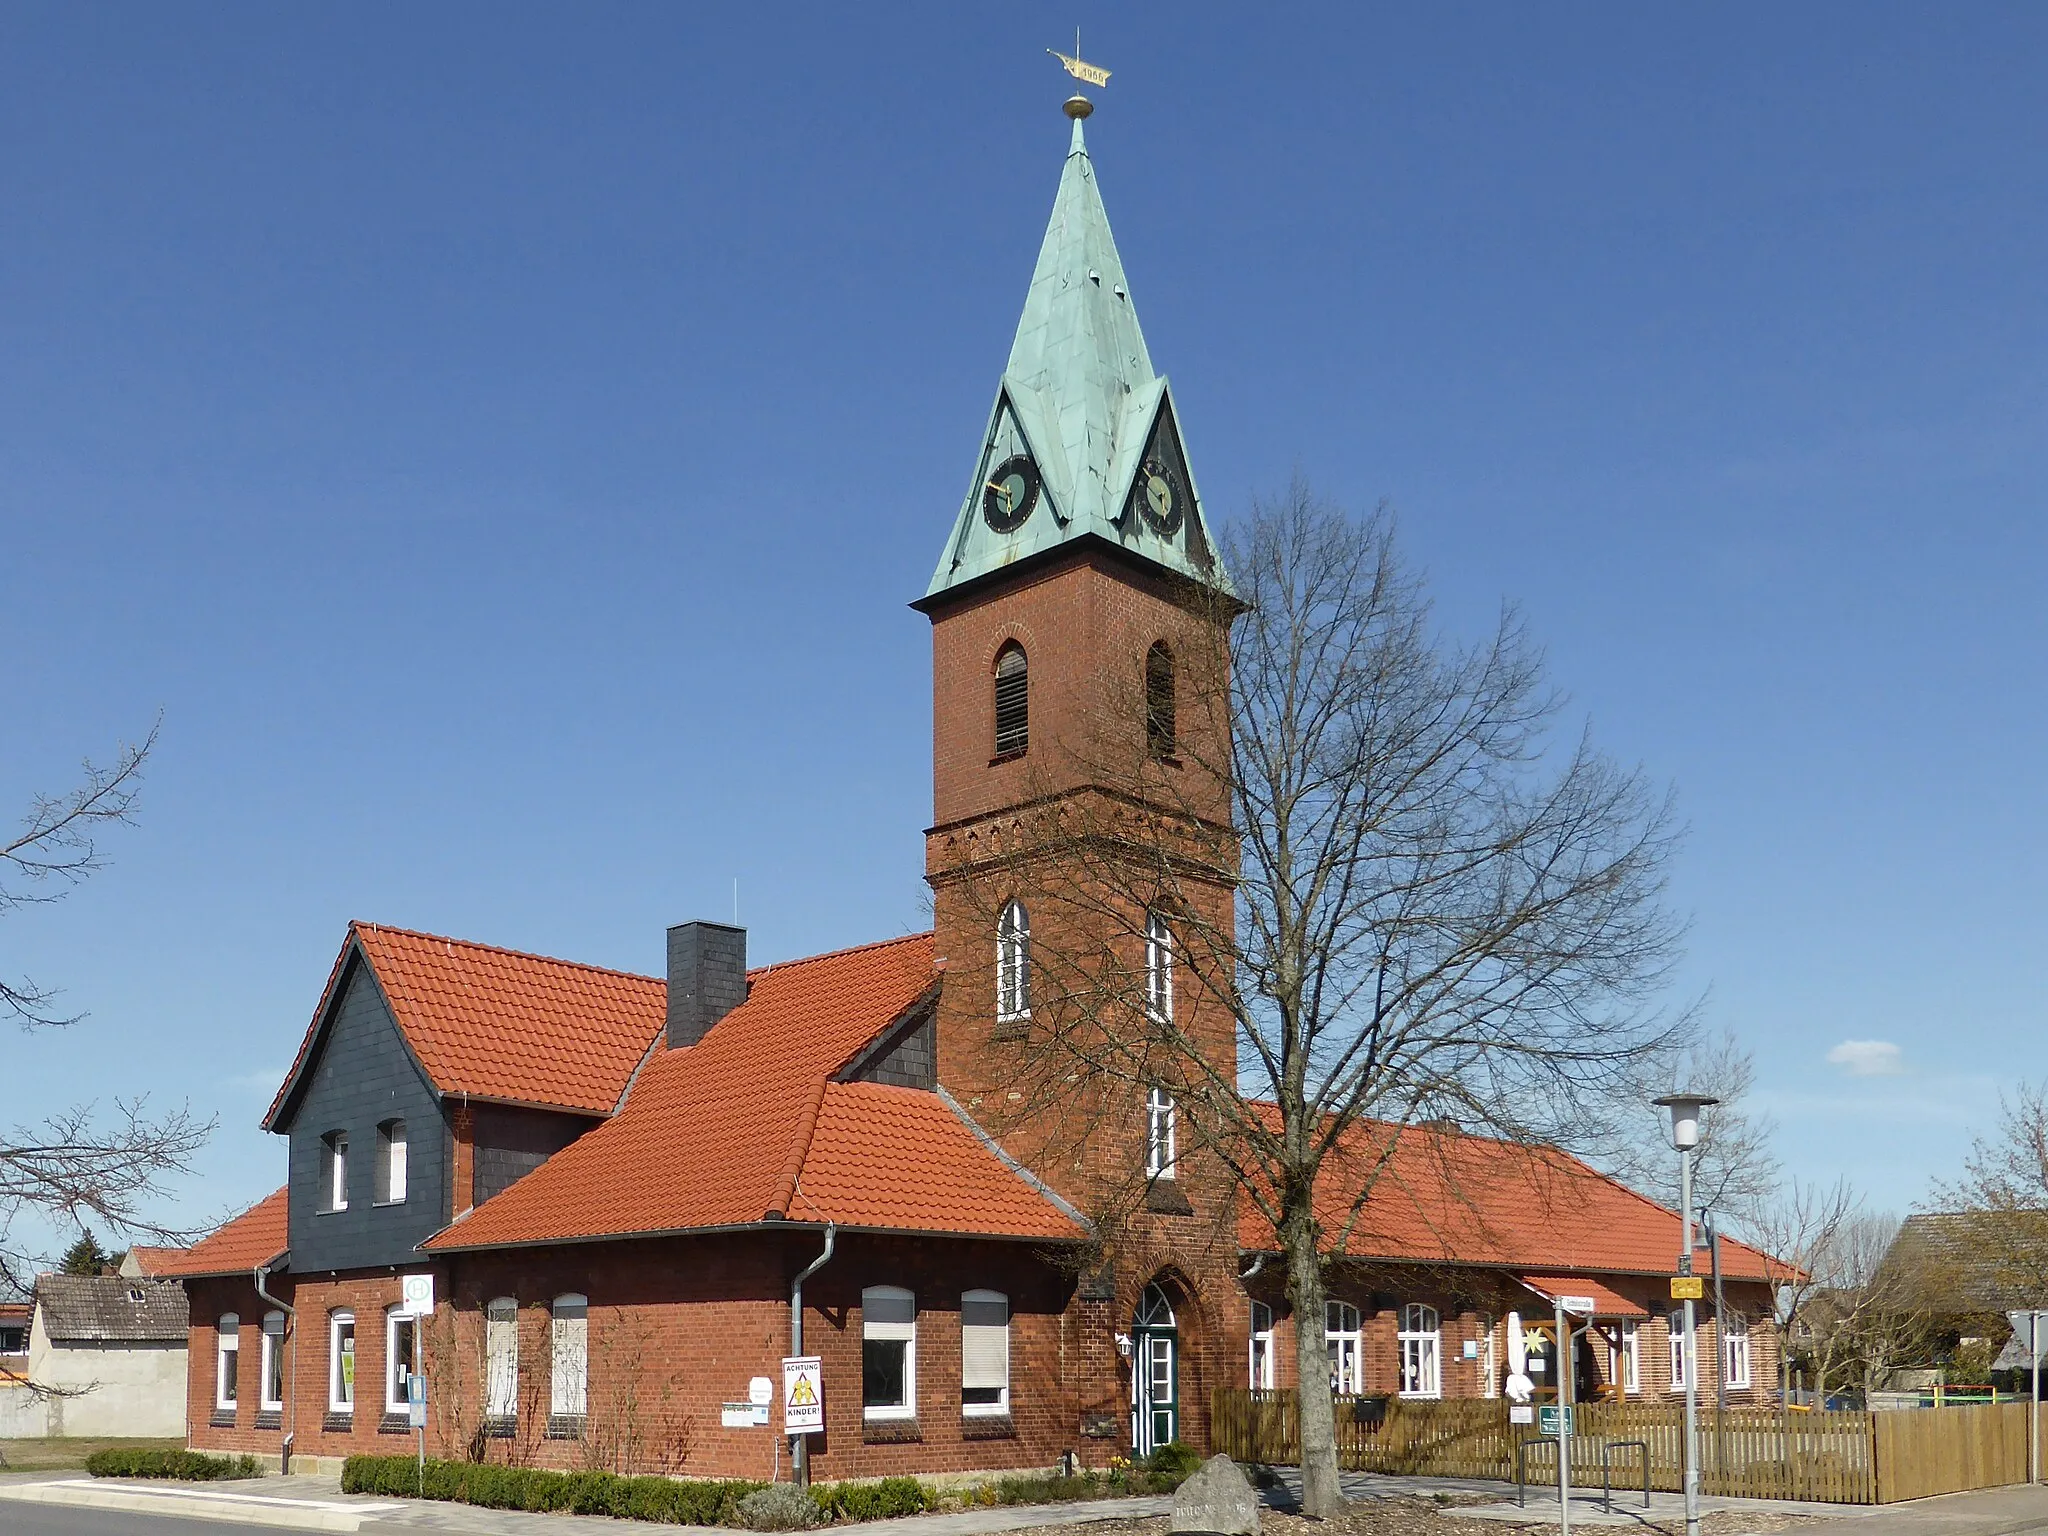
{"left": 168, "top": 105, "right": 1774, "bottom": 1479}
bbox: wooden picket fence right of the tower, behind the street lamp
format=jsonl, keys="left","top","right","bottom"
{"left": 1210, "top": 1389, "right": 2028, "bottom": 1503}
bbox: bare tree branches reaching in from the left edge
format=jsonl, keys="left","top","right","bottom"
{"left": 0, "top": 727, "right": 213, "bottom": 1290}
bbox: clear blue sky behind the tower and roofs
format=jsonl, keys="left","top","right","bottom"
{"left": 0, "top": 4, "right": 2048, "bottom": 1253}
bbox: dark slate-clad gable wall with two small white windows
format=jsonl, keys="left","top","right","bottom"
{"left": 279, "top": 954, "right": 449, "bottom": 1274}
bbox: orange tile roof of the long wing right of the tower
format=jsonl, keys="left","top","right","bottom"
{"left": 1237, "top": 1120, "right": 1769, "bottom": 1280}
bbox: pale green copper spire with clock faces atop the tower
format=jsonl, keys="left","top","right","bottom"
{"left": 926, "top": 117, "right": 1229, "bottom": 598}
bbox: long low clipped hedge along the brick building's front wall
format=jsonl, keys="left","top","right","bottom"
{"left": 342, "top": 1456, "right": 766, "bottom": 1526}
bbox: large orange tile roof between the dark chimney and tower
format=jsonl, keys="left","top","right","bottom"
{"left": 424, "top": 934, "right": 1081, "bottom": 1249}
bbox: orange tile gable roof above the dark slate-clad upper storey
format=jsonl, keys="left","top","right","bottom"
{"left": 264, "top": 922, "right": 668, "bottom": 1130}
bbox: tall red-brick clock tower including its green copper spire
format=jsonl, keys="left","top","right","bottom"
{"left": 913, "top": 98, "right": 1247, "bottom": 1450}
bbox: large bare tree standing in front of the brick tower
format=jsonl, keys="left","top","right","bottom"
{"left": 971, "top": 481, "right": 1690, "bottom": 1516}
